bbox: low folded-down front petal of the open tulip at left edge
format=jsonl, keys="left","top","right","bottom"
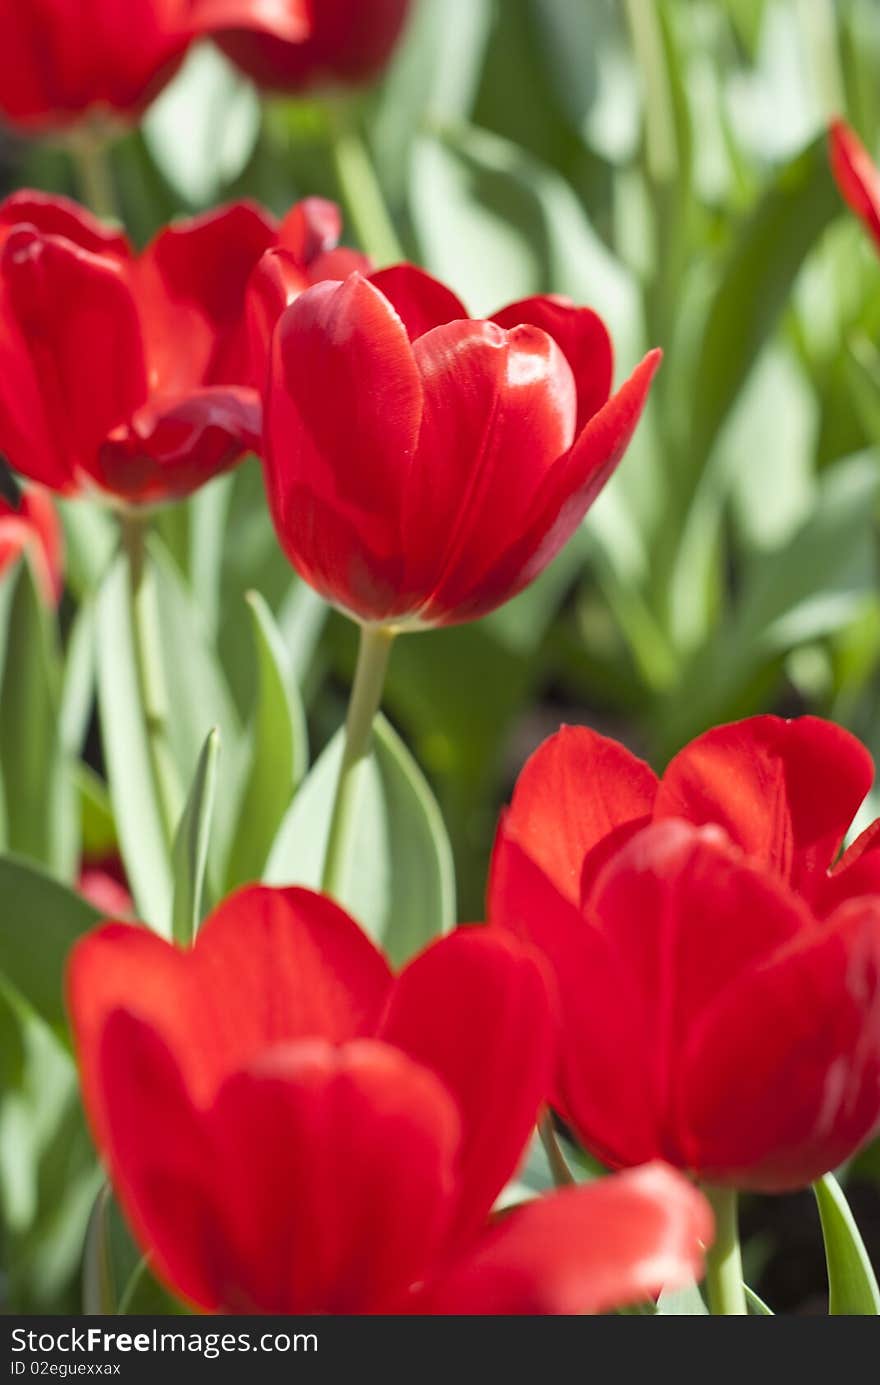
{"left": 91, "top": 385, "right": 262, "bottom": 504}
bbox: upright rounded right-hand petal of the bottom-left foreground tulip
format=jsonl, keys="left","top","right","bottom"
{"left": 380, "top": 928, "right": 554, "bottom": 1237}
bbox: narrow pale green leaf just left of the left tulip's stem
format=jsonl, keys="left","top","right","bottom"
{"left": 97, "top": 554, "right": 172, "bottom": 929}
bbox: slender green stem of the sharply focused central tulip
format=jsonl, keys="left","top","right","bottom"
{"left": 322, "top": 625, "right": 394, "bottom": 899}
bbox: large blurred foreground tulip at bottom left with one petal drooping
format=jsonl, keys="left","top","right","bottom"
{"left": 68, "top": 886, "right": 711, "bottom": 1313}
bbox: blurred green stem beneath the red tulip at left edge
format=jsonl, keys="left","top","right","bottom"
{"left": 121, "top": 514, "right": 183, "bottom": 849}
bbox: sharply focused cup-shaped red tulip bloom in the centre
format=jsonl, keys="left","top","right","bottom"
{"left": 257, "top": 265, "right": 660, "bottom": 627}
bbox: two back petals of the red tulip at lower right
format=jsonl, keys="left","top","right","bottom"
{"left": 487, "top": 716, "right": 880, "bottom": 918}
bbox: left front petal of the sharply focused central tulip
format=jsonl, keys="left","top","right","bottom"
{"left": 266, "top": 274, "right": 423, "bottom": 619}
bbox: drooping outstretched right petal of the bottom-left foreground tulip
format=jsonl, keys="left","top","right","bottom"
{"left": 417, "top": 1163, "right": 714, "bottom": 1314}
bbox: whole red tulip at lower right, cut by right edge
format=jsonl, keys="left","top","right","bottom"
{"left": 489, "top": 717, "right": 880, "bottom": 1191}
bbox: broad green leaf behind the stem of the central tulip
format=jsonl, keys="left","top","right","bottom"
{"left": 265, "top": 716, "right": 456, "bottom": 964}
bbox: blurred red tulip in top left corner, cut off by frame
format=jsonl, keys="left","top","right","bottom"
{"left": 0, "top": 0, "right": 309, "bottom": 132}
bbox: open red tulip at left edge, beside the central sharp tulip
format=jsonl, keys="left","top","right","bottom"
{"left": 0, "top": 193, "right": 350, "bottom": 503}
